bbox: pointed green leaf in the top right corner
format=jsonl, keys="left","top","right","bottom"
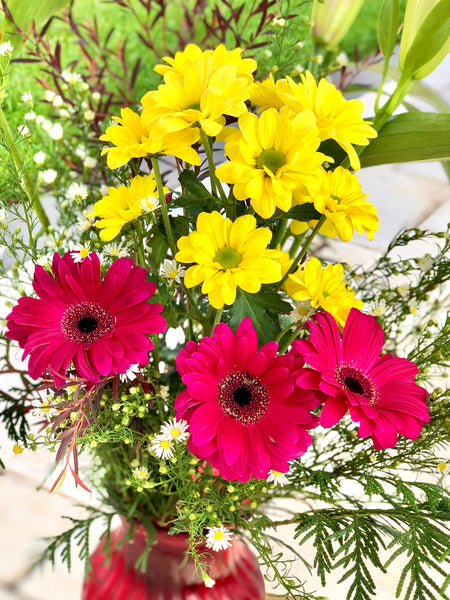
{"left": 402, "top": 0, "right": 450, "bottom": 79}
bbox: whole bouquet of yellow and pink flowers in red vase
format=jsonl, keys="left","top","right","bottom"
{"left": 0, "top": 0, "right": 450, "bottom": 600}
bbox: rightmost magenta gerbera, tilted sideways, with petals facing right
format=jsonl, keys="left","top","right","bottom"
{"left": 292, "top": 308, "right": 429, "bottom": 450}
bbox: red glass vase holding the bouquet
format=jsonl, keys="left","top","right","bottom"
{"left": 83, "top": 522, "right": 264, "bottom": 600}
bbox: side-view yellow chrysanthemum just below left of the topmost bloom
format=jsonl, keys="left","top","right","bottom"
{"left": 100, "top": 108, "right": 201, "bottom": 169}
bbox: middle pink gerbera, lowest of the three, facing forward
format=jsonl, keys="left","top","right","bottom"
{"left": 175, "top": 318, "right": 320, "bottom": 481}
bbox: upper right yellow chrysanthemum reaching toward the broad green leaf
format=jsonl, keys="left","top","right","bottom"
{"left": 250, "top": 71, "right": 377, "bottom": 170}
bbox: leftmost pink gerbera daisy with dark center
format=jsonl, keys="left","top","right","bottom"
{"left": 6, "top": 252, "right": 166, "bottom": 386}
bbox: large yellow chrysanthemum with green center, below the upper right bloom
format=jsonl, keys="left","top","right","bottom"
{"left": 216, "top": 108, "right": 327, "bottom": 219}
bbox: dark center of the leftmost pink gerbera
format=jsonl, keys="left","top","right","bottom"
{"left": 61, "top": 302, "right": 114, "bottom": 344}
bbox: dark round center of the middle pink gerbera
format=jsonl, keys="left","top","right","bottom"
{"left": 217, "top": 371, "right": 270, "bottom": 425}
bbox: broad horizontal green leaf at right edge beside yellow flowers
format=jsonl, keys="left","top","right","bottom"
{"left": 361, "top": 113, "right": 450, "bottom": 167}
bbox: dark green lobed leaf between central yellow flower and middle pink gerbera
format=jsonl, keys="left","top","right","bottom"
{"left": 230, "top": 290, "right": 291, "bottom": 344}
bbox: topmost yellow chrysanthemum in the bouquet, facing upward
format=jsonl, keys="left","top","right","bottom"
{"left": 141, "top": 44, "right": 255, "bottom": 141}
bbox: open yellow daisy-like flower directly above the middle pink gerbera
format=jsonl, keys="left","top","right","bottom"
{"left": 175, "top": 211, "right": 281, "bottom": 308}
